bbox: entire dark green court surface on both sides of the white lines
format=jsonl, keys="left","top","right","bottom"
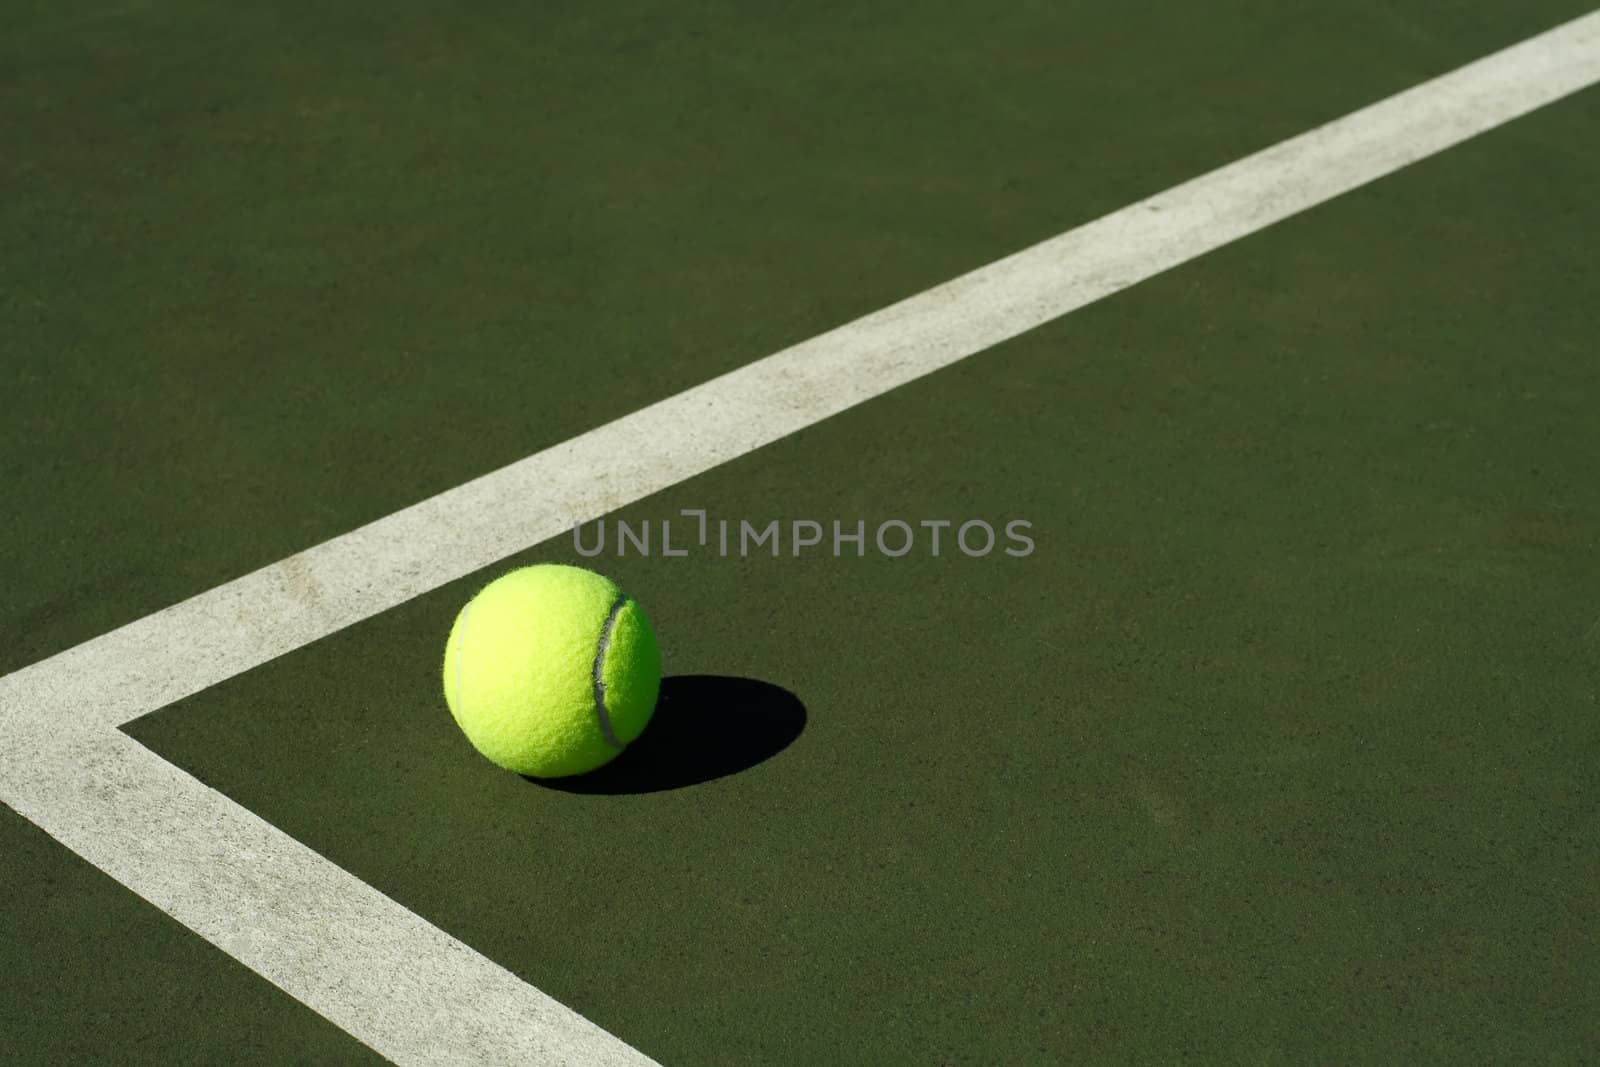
{"left": 0, "top": 0, "right": 1600, "bottom": 1064}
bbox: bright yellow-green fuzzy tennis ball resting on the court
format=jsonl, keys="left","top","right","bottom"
{"left": 445, "top": 563, "right": 661, "bottom": 777}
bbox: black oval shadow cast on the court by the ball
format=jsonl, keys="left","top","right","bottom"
{"left": 528, "top": 675, "right": 806, "bottom": 795}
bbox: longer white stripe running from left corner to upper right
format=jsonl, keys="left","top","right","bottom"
{"left": 0, "top": 11, "right": 1600, "bottom": 742}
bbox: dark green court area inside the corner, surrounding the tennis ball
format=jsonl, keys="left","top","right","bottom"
{"left": 133, "top": 79, "right": 1600, "bottom": 1064}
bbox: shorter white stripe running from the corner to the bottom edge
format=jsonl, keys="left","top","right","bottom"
{"left": 0, "top": 720, "right": 654, "bottom": 1067}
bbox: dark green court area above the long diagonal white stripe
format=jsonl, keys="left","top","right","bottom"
{"left": 0, "top": 0, "right": 1587, "bottom": 670}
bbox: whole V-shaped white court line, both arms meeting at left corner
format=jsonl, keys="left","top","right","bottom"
{"left": 9, "top": 13, "right": 1600, "bottom": 1064}
